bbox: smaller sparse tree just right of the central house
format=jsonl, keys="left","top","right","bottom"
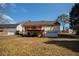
{"left": 57, "top": 14, "right": 69, "bottom": 31}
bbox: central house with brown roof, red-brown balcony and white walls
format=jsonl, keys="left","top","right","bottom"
{"left": 17, "top": 21, "right": 60, "bottom": 37}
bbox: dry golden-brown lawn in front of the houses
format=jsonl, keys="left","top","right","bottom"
{"left": 0, "top": 36, "right": 79, "bottom": 56}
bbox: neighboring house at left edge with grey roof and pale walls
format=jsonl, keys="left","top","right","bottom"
{"left": 0, "top": 24, "right": 18, "bottom": 35}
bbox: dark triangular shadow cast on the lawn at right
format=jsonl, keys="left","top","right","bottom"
{"left": 45, "top": 40, "right": 79, "bottom": 52}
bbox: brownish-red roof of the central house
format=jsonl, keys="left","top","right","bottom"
{"left": 23, "top": 21, "right": 60, "bottom": 26}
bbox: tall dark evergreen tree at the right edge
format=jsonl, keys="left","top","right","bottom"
{"left": 70, "top": 3, "right": 79, "bottom": 33}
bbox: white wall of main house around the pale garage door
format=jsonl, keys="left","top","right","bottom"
{"left": 42, "top": 26, "right": 60, "bottom": 37}
